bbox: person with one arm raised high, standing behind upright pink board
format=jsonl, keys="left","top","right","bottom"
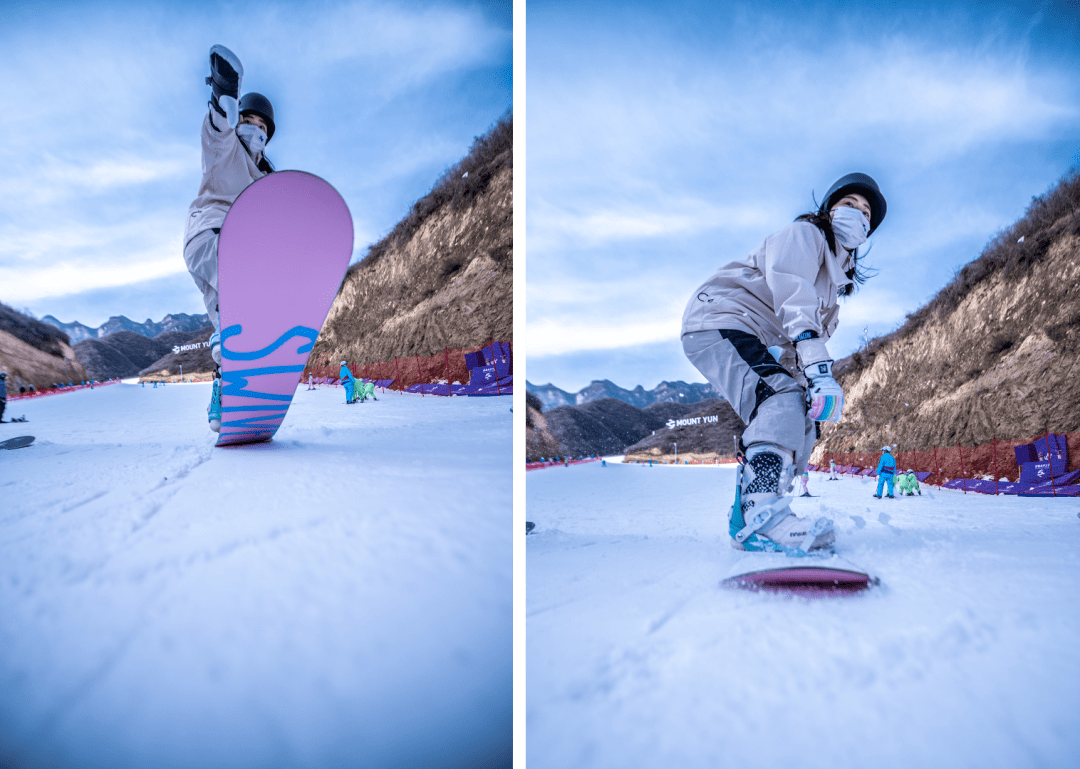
{"left": 184, "top": 45, "right": 274, "bottom": 432}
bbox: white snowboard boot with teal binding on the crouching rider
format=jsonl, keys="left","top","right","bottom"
{"left": 728, "top": 444, "right": 836, "bottom": 555}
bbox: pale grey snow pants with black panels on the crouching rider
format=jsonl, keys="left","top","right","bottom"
{"left": 683, "top": 329, "right": 818, "bottom": 474}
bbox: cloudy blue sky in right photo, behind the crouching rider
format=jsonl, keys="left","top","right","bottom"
{"left": 525, "top": 0, "right": 1080, "bottom": 392}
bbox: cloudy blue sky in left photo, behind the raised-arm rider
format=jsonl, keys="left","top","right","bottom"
{"left": 0, "top": 0, "right": 513, "bottom": 326}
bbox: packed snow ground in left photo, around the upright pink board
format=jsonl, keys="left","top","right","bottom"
{"left": 0, "top": 383, "right": 513, "bottom": 769}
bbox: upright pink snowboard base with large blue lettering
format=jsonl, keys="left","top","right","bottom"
{"left": 217, "top": 171, "right": 352, "bottom": 446}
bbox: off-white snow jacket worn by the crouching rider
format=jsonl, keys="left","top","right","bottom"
{"left": 683, "top": 221, "right": 855, "bottom": 369}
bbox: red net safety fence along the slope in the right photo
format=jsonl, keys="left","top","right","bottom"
{"left": 821, "top": 431, "right": 1080, "bottom": 486}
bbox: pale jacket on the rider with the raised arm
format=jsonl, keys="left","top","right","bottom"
{"left": 184, "top": 107, "right": 273, "bottom": 246}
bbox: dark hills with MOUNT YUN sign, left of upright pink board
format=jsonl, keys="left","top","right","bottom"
{"left": 75, "top": 326, "right": 214, "bottom": 379}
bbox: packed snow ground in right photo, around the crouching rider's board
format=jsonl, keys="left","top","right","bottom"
{"left": 525, "top": 459, "right": 1080, "bottom": 769}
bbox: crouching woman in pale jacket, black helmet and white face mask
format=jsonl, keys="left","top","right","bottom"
{"left": 683, "top": 173, "right": 886, "bottom": 554}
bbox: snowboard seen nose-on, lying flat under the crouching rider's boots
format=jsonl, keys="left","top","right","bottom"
{"left": 720, "top": 553, "right": 880, "bottom": 595}
